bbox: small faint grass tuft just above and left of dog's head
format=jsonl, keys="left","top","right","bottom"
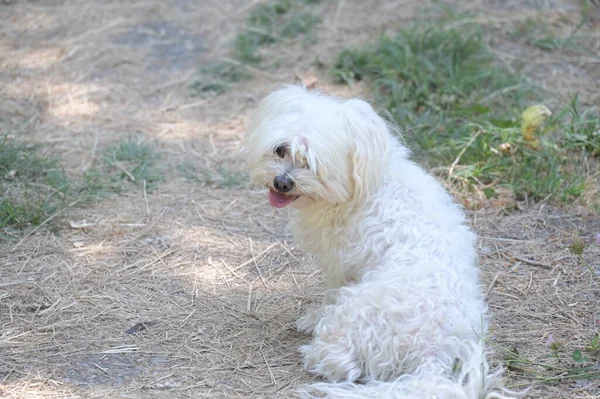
{"left": 190, "top": 62, "right": 252, "bottom": 97}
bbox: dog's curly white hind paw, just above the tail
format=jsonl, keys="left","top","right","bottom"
{"left": 300, "top": 341, "right": 362, "bottom": 382}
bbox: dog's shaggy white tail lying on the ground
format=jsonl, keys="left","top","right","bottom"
{"left": 299, "top": 342, "right": 522, "bottom": 399}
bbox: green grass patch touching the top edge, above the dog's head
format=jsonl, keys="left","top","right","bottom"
{"left": 233, "top": 0, "right": 320, "bottom": 64}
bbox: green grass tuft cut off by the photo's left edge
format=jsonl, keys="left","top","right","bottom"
{"left": 0, "top": 135, "right": 72, "bottom": 236}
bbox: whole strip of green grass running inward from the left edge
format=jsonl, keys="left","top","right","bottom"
{"left": 0, "top": 135, "right": 162, "bottom": 239}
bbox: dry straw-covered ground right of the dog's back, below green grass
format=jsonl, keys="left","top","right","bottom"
{"left": 472, "top": 205, "right": 600, "bottom": 398}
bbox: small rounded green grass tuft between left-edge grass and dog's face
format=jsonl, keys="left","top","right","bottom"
{"left": 104, "top": 137, "right": 162, "bottom": 187}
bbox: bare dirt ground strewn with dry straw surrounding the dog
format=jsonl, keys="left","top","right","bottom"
{"left": 0, "top": 0, "right": 600, "bottom": 398}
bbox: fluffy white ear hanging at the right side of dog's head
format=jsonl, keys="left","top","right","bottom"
{"left": 342, "top": 100, "right": 393, "bottom": 200}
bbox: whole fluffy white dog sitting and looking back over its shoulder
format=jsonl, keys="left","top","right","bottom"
{"left": 244, "top": 86, "right": 506, "bottom": 399}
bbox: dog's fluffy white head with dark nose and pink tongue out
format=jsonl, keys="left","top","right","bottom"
{"left": 243, "top": 86, "right": 400, "bottom": 208}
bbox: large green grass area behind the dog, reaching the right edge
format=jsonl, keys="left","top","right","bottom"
{"left": 333, "top": 26, "right": 600, "bottom": 205}
